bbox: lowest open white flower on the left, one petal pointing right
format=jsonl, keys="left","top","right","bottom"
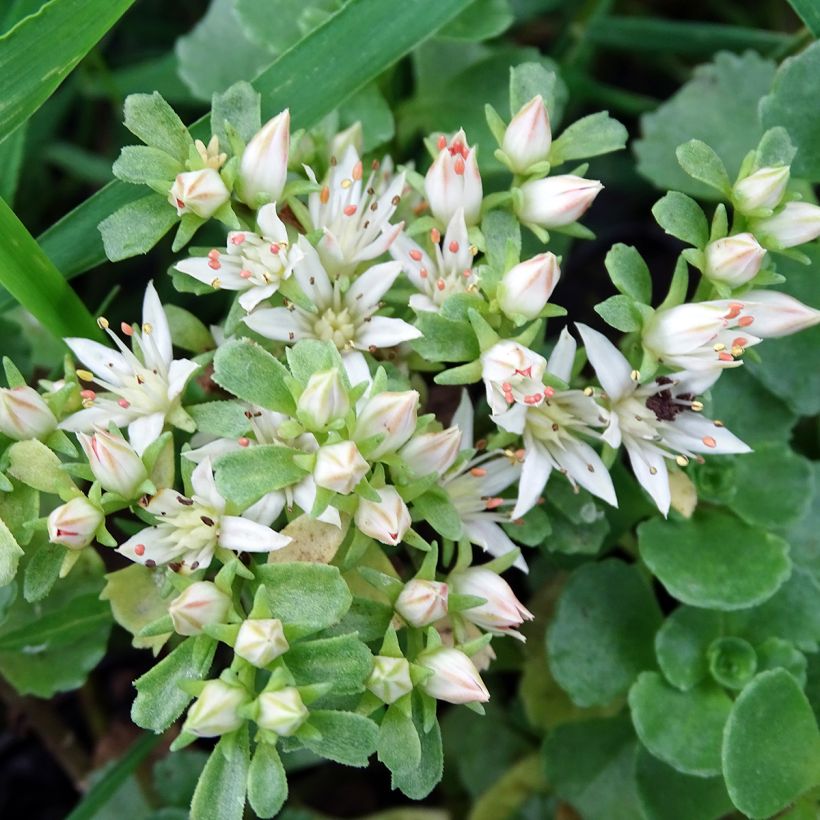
{"left": 117, "top": 458, "right": 291, "bottom": 571}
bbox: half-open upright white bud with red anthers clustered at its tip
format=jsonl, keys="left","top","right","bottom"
{"left": 424, "top": 129, "right": 484, "bottom": 225}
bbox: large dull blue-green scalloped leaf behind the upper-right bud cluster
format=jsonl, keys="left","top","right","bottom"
{"left": 635, "top": 52, "right": 775, "bottom": 200}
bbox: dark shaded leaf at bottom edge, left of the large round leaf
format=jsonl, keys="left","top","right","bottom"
{"left": 635, "top": 746, "right": 732, "bottom": 820}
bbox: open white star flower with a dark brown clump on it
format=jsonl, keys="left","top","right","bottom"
{"left": 578, "top": 324, "right": 750, "bottom": 515}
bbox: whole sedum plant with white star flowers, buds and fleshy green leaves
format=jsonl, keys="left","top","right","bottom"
{"left": 0, "top": 54, "right": 820, "bottom": 818}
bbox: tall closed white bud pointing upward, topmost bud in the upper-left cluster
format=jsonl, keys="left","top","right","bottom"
{"left": 237, "top": 109, "right": 290, "bottom": 208}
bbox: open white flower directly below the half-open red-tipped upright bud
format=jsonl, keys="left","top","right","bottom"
{"left": 390, "top": 208, "right": 478, "bottom": 313}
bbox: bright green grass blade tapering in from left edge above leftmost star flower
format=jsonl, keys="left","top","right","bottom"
{"left": 0, "top": 199, "right": 100, "bottom": 338}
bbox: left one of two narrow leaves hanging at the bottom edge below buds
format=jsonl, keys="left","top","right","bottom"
{"left": 191, "top": 728, "right": 250, "bottom": 820}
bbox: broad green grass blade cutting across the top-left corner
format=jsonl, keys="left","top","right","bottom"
{"left": 0, "top": 0, "right": 134, "bottom": 139}
